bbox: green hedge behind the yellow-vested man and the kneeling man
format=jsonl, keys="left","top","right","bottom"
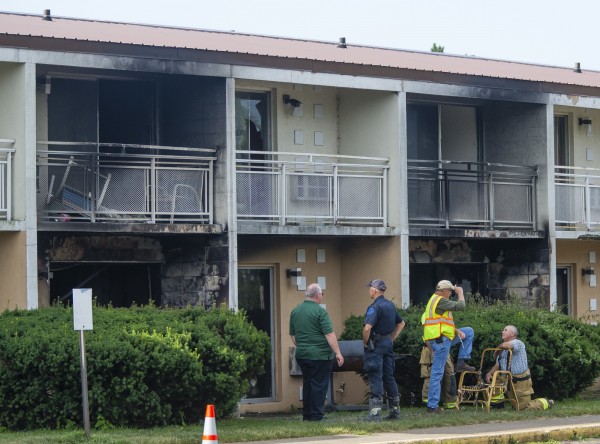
{"left": 340, "top": 301, "right": 600, "bottom": 404}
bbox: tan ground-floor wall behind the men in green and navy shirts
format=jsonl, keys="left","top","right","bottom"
{"left": 238, "top": 237, "right": 400, "bottom": 412}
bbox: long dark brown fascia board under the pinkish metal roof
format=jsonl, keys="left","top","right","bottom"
{"left": 0, "top": 34, "right": 600, "bottom": 97}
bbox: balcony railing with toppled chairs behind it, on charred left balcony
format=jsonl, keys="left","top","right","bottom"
{"left": 37, "top": 142, "right": 216, "bottom": 224}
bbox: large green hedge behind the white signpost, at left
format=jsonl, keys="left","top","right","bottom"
{"left": 0, "top": 307, "right": 270, "bottom": 430}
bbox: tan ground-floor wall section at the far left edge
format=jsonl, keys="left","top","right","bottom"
{"left": 0, "top": 231, "right": 27, "bottom": 312}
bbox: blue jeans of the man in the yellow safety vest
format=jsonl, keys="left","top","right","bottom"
{"left": 427, "top": 327, "right": 474, "bottom": 409}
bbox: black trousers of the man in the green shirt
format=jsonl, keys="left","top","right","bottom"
{"left": 298, "top": 359, "right": 333, "bottom": 421}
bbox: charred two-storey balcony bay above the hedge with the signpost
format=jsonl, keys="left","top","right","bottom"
{"left": 36, "top": 73, "right": 229, "bottom": 307}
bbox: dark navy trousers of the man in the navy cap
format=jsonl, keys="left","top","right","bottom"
{"left": 363, "top": 338, "right": 398, "bottom": 401}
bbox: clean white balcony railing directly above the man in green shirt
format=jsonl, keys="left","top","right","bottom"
{"left": 236, "top": 151, "right": 389, "bottom": 227}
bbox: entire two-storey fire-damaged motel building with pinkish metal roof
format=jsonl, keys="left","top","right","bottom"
{"left": 0, "top": 12, "right": 600, "bottom": 412}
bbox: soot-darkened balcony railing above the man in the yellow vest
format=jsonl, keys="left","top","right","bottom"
{"left": 408, "top": 160, "right": 537, "bottom": 230}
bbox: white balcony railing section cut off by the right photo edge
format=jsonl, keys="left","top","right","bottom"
{"left": 554, "top": 166, "right": 600, "bottom": 231}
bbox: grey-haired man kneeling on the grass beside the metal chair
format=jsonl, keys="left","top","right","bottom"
{"left": 485, "top": 325, "right": 554, "bottom": 410}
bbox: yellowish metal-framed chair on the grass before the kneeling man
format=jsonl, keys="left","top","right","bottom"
{"left": 456, "top": 348, "right": 518, "bottom": 413}
